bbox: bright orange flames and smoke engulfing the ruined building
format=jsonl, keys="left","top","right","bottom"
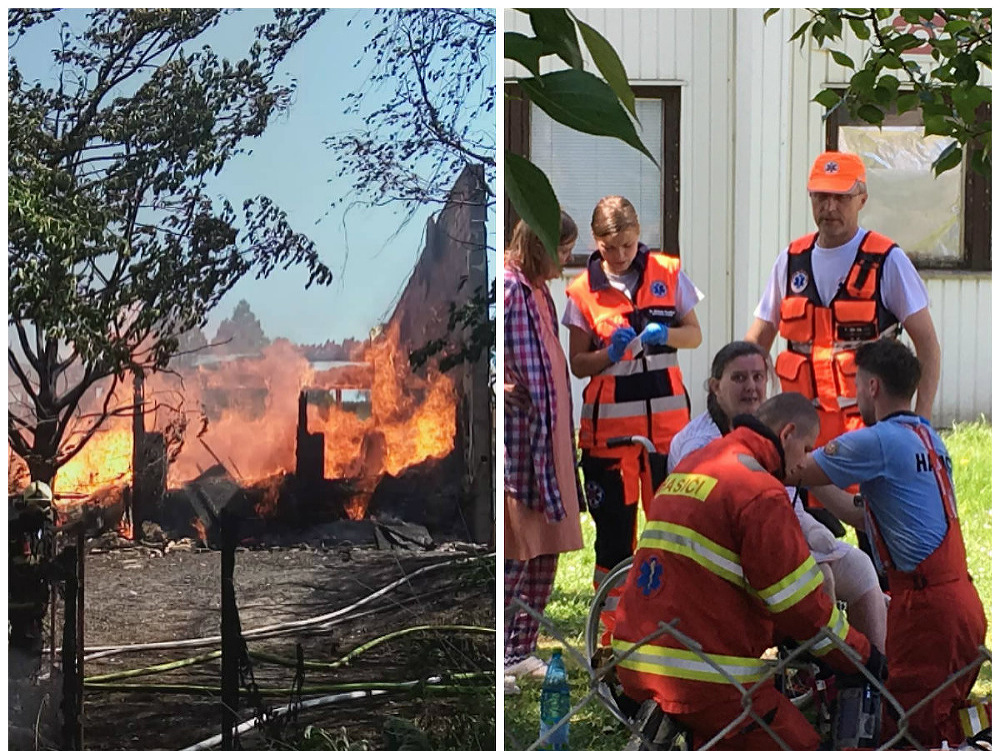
{"left": 21, "top": 324, "right": 457, "bottom": 524}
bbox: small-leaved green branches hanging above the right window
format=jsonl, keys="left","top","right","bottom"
{"left": 764, "top": 8, "right": 993, "bottom": 175}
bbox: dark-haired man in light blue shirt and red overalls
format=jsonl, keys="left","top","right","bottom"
{"left": 791, "top": 340, "right": 986, "bottom": 748}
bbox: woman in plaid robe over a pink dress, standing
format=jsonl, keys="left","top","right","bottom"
{"left": 503, "top": 212, "right": 583, "bottom": 693}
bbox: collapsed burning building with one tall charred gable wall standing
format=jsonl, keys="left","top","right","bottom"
{"left": 7, "top": 164, "right": 493, "bottom": 542}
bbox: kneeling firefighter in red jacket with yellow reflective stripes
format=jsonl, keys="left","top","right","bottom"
{"left": 612, "top": 393, "right": 885, "bottom": 751}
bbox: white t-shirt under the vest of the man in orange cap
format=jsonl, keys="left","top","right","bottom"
{"left": 754, "top": 227, "right": 928, "bottom": 328}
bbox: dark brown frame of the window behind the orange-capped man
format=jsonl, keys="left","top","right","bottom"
{"left": 826, "top": 97, "right": 993, "bottom": 273}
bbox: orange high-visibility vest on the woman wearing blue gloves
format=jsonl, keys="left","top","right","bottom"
{"left": 566, "top": 250, "right": 691, "bottom": 454}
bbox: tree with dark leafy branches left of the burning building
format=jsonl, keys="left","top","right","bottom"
{"left": 7, "top": 8, "right": 331, "bottom": 482}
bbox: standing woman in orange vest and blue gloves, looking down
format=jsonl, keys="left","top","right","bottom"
{"left": 562, "top": 196, "right": 703, "bottom": 644}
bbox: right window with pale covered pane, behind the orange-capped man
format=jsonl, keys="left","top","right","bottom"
{"left": 826, "top": 101, "right": 992, "bottom": 271}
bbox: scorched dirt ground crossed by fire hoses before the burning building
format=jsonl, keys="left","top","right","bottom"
{"left": 30, "top": 543, "right": 495, "bottom": 751}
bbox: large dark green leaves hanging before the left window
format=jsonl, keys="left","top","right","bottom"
{"left": 503, "top": 8, "right": 656, "bottom": 257}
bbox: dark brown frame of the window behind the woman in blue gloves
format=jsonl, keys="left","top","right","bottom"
{"left": 504, "top": 83, "right": 681, "bottom": 268}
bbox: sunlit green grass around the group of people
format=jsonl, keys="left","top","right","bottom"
{"left": 504, "top": 420, "right": 993, "bottom": 751}
